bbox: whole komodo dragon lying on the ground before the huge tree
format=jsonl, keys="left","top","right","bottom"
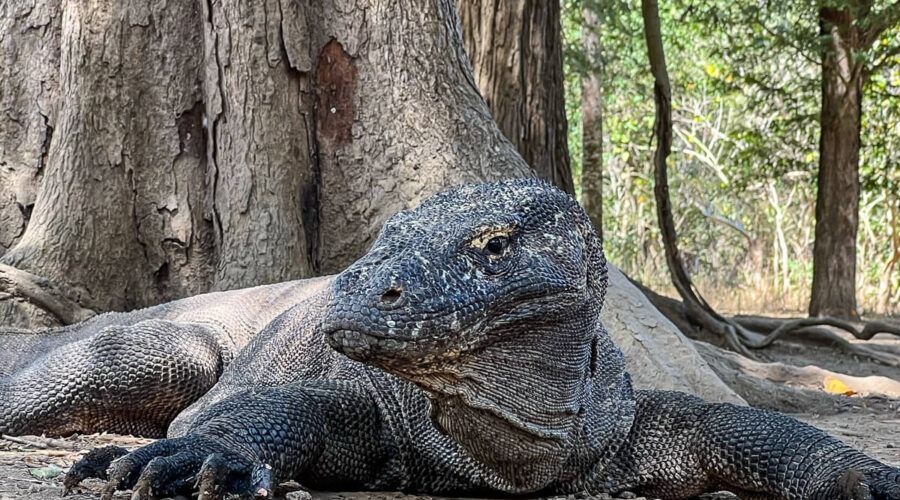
{"left": 0, "top": 180, "right": 900, "bottom": 500}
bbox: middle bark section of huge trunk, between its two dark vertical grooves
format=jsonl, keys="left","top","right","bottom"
{"left": 201, "top": 0, "right": 317, "bottom": 290}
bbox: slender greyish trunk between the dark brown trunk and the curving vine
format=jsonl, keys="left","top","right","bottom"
{"left": 581, "top": 9, "right": 603, "bottom": 240}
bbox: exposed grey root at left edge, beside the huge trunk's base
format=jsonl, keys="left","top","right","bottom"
{"left": 0, "top": 264, "right": 97, "bottom": 325}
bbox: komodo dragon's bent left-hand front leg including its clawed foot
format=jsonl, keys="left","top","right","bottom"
{"left": 65, "top": 381, "right": 390, "bottom": 499}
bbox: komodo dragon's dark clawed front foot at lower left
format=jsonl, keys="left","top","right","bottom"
{"left": 64, "top": 436, "right": 274, "bottom": 500}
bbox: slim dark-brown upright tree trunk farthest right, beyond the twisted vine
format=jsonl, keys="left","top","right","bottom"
{"left": 809, "top": 7, "right": 863, "bottom": 319}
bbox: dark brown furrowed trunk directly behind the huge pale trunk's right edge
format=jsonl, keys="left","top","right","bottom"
{"left": 458, "top": 0, "right": 574, "bottom": 193}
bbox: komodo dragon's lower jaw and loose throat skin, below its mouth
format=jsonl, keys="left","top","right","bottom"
{"left": 326, "top": 304, "right": 597, "bottom": 493}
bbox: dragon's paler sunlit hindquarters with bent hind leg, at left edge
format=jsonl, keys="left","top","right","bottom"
{"left": 0, "top": 278, "right": 330, "bottom": 437}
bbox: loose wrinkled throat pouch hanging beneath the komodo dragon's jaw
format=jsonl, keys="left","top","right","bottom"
{"left": 417, "top": 311, "right": 605, "bottom": 493}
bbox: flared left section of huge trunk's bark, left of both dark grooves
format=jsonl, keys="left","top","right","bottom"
{"left": 2, "top": 1, "right": 211, "bottom": 322}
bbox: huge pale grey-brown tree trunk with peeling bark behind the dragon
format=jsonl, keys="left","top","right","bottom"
{"left": 0, "top": 0, "right": 530, "bottom": 326}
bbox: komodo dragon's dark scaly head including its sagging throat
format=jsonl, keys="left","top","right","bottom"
{"left": 324, "top": 179, "right": 630, "bottom": 491}
